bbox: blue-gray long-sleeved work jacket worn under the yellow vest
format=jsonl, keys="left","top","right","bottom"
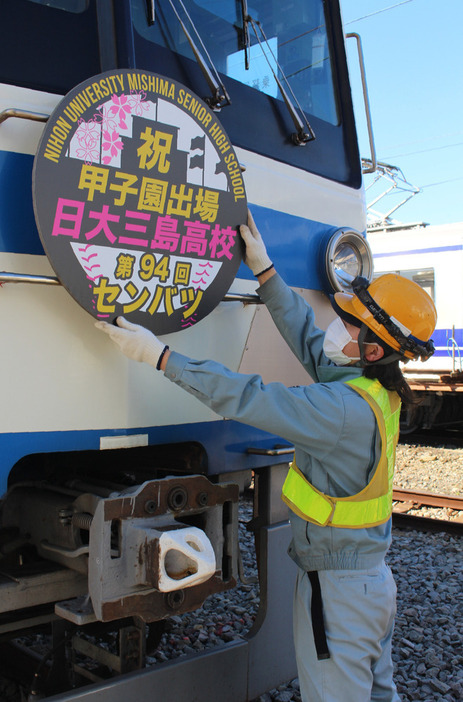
{"left": 165, "top": 275, "right": 391, "bottom": 570}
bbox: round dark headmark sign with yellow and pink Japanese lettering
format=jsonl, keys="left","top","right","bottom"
{"left": 33, "top": 70, "right": 247, "bottom": 334}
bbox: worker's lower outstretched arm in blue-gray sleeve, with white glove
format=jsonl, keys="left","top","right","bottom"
{"left": 96, "top": 317, "right": 345, "bottom": 457}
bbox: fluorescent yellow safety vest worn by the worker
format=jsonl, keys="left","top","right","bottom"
{"left": 282, "top": 376, "right": 401, "bottom": 529}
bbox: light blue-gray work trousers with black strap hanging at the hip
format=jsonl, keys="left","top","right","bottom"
{"left": 293, "top": 563, "right": 400, "bottom": 702}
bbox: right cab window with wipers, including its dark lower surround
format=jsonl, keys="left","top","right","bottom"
{"left": 130, "top": 0, "right": 361, "bottom": 187}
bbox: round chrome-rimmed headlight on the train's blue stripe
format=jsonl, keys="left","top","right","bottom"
{"left": 325, "top": 228, "right": 373, "bottom": 292}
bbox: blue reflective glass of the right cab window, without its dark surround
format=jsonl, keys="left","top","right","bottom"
{"left": 132, "top": 0, "right": 338, "bottom": 124}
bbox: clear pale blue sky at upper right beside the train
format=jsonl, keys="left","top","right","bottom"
{"left": 340, "top": 0, "right": 463, "bottom": 224}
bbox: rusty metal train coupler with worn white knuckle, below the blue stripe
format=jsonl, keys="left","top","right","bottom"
{"left": 56, "top": 476, "right": 238, "bottom": 624}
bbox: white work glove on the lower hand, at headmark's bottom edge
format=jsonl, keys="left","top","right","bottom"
{"left": 95, "top": 317, "right": 169, "bottom": 370}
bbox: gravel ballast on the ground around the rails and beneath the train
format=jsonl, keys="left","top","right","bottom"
{"left": 154, "top": 444, "right": 463, "bottom": 702}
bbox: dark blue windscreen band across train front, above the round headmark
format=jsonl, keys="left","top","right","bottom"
{"left": 0, "top": 0, "right": 362, "bottom": 188}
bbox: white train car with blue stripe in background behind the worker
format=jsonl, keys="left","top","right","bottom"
{"left": 368, "top": 222, "right": 463, "bottom": 433}
